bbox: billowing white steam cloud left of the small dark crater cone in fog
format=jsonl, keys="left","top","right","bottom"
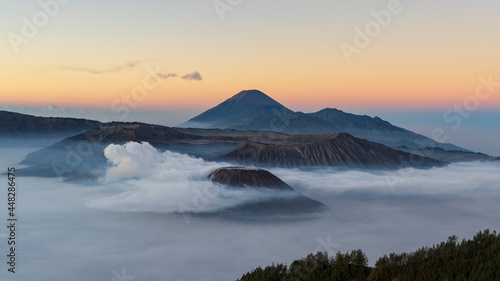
{"left": 88, "top": 142, "right": 272, "bottom": 213}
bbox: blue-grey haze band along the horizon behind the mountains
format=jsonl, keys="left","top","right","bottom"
{"left": 0, "top": 102, "right": 500, "bottom": 156}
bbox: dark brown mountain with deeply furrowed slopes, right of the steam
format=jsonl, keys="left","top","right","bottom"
{"left": 215, "top": 133, "right": 446, "bottom": 169}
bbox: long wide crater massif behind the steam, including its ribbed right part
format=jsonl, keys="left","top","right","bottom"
{"left": 20, "top": 124, "right": 444, "bottom": 181}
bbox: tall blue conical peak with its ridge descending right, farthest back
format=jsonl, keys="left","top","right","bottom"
{"left": 180, "top": 90, "right": 469, "bottom": 151}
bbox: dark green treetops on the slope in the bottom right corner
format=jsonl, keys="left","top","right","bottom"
{"left": 238, "top": 230, "right": 500, "bottom": 281}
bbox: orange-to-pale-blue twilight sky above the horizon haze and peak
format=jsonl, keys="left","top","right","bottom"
{"left": 0, "top": 0, "right": 500, "bottom": 153}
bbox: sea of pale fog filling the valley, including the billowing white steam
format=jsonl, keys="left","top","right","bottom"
{"left": 0, "top": 142, "right": 500, "bottom": 281}
